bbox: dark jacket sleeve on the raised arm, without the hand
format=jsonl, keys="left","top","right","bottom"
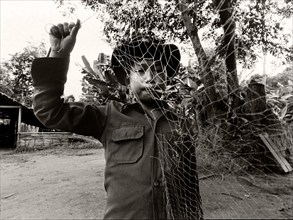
{"left": 31, "top": 58, "right": 107, "bottom": 139}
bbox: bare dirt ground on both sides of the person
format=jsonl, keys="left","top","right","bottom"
{"left": 0, "top": 148, "right": 293, "bottom": 220}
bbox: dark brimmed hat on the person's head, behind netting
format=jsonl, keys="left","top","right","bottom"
{"left": 111, "top": 41, "right": 181, "bottom": 85}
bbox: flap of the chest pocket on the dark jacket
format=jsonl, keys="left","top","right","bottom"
{"left": 112, "top": 127, "right": 143, "bottom": 141}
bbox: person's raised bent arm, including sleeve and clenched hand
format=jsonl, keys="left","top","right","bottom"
{"left": 31, "top": 21, "right": 107, "bottom": 139}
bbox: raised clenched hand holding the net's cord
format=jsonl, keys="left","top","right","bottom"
{"left": 49, "top": 20, "right": 80, "bottom": 57}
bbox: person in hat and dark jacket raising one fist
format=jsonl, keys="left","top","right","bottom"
{"left": 31, "top": 20, "right": 203, "bottom": 219}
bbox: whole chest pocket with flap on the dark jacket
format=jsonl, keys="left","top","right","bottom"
{"left": 112, "top": 126, "right": 144, "bottom": 163}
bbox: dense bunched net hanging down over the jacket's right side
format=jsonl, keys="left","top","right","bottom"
{"left": 160, "top": 132, "right": 202, "bottom": 219}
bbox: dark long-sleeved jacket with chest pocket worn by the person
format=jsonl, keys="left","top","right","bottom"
{"left": 32, "top": 58, "right": 202, "bottom": 219}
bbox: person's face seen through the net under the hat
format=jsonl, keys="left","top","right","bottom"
{"left": 129, "top": 58, "right": 167, "bottom": 104}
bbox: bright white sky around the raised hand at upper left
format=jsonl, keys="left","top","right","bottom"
{"left": 0, "top": 0, "right": 112, "bottom": 98}
